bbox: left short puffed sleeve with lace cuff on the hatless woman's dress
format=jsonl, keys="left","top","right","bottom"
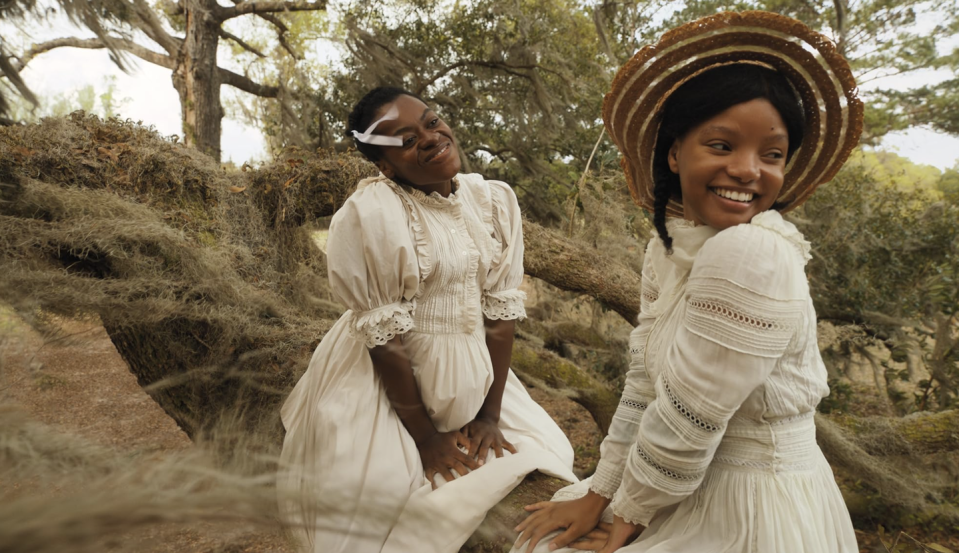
{"left": 327, "top": 183, "right": 419, "bottom": 348}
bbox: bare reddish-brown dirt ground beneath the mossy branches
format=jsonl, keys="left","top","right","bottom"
{"left": 0, "top": 312, "right": 953, "bottom": 553}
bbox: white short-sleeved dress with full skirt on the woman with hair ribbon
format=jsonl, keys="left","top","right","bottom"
{"left": 278, "top": 175, "right": 576, "bottom": 553}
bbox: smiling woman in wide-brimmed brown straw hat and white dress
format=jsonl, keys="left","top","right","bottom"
{"left": 515, "top": 12, "right": 862, "bottom": 553}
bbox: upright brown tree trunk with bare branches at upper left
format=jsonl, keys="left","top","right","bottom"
{"left": 173, "top": 0, "right": 223, "bottom": 161}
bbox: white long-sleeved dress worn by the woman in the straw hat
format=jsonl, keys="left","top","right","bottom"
{"left": 512, "top": 211, "right": 859, "bottom": 553}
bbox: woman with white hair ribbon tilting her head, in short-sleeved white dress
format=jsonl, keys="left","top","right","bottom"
{"left": 280, "top": 88, "right": 576, "bottom": 553}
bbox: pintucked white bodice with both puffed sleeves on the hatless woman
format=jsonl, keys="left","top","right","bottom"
{"left": 328, "top": 175, "right": 526, "bottom": 347}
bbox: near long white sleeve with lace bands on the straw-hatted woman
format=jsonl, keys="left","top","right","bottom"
{"left": 612, "top": 225, "right": 809, "bottom": 525}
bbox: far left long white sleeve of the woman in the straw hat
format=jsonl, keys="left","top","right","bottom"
{"left": 589, "top": 237, "right": 663, "bottom": 499}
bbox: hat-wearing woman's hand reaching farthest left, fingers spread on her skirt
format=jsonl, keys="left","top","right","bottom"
{"left": 515, "top": 491, "right": 609, "bottom": 552}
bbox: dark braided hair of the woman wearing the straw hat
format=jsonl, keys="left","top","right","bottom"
{"left": 653, "top": 63, "right": 805, "bottom": 251}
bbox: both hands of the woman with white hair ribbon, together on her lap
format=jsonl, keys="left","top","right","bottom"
{"left": 417, "top": 418, "right": 516, "bottom": 489}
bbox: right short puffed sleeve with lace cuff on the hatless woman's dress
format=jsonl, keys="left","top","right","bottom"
{"left": 483, "top": 181, "right": 526, "bottom": 320}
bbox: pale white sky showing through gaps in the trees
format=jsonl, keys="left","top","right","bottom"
{"left": 0, "top": 7, "right": 959, "bottom": 170}
